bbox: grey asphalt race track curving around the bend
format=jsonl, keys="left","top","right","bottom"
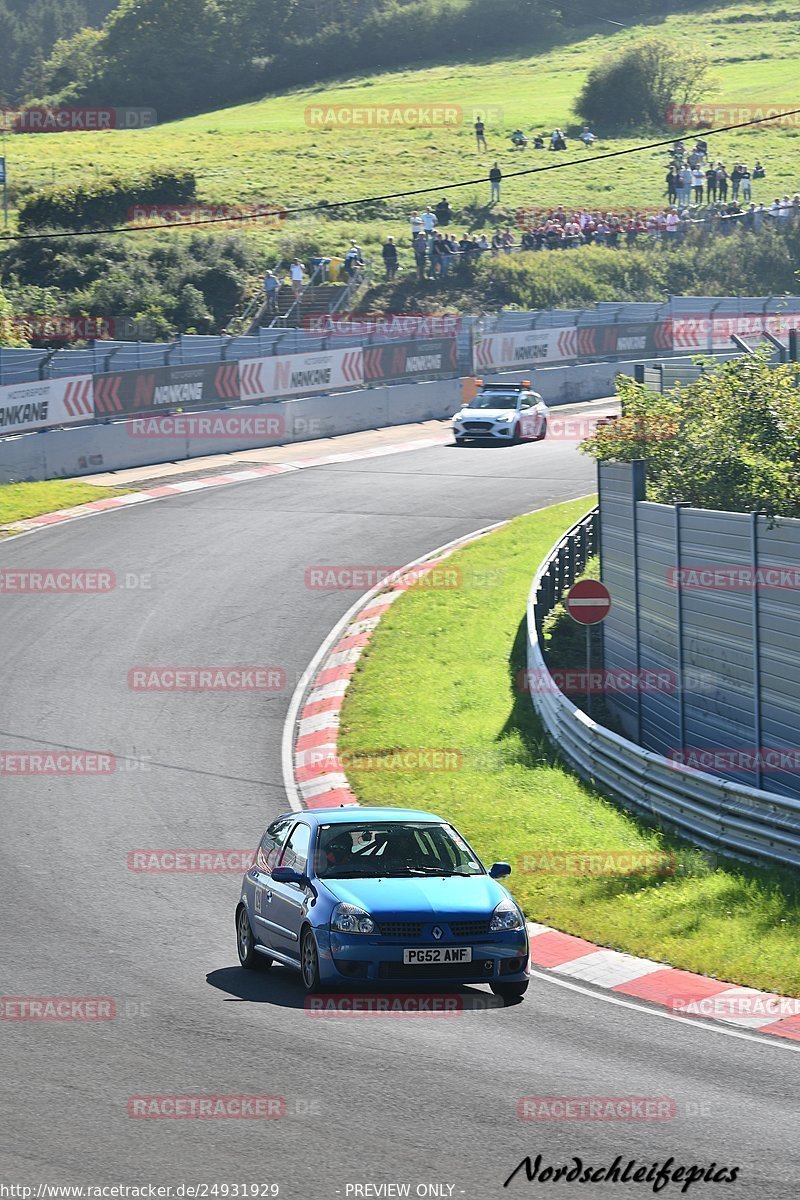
{"left": 0, "top": 440, "right": 800, "bottom": 1200}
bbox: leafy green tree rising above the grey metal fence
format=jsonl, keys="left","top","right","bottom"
{"left": 581, "top": 352, "right": 800, "bottom": 516}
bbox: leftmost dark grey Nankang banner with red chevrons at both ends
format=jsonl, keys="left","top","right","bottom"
{"left": 95, "top": 362, "right": 240, "bottom": 418}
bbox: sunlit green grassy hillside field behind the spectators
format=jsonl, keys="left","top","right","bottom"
{"left": 4, "top": 0, "right": 800, "bottom": 264}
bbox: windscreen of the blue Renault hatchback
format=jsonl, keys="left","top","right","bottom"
{"left": 314, "top": 821, "right": 483, "bottom": 880}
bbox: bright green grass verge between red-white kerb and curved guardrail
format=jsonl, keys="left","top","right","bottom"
{"left": 341, "top": 499, "right": 800, "bottom": 995}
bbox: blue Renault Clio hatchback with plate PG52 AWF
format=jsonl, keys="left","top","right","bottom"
{"left": 236, "top": 805, "right": 529, "bottom": 1000}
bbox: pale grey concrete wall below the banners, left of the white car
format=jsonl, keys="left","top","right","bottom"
{"left": 0, "top": 379, "right": 461, "bottom": 484}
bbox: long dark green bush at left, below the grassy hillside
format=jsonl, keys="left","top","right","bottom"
{"left": 19, "top": 170, "right": 197, "bottom": 230}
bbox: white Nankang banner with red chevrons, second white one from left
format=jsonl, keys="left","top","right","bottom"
{"left": 239, "top": 347, "right": 363, "bottom": 401}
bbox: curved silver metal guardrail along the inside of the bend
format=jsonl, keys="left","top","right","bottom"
{"left": 528, "top": 509, "right": 800, "bottom": 866}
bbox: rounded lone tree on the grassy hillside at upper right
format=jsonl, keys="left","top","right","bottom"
{"left": 575, "top": 37, "right": 709, "bottom": 131}
